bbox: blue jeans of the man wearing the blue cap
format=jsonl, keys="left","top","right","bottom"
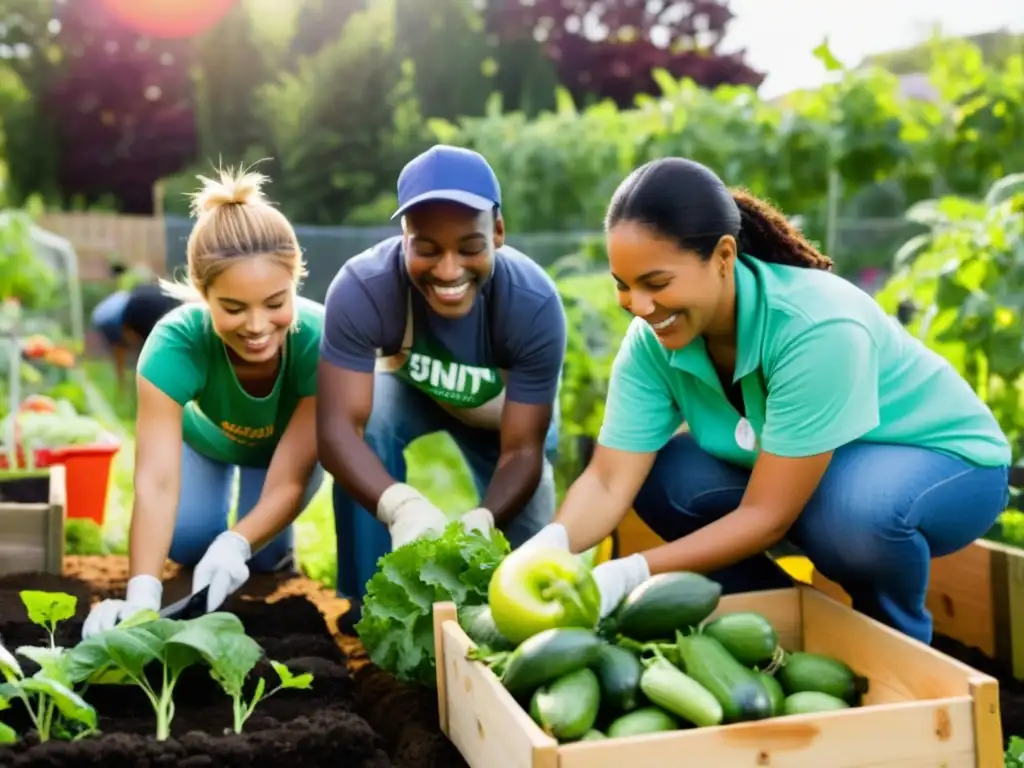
{"left": 334, "top": 372, "right": 558, "bottom": 600}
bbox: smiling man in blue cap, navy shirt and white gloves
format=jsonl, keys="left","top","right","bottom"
{"left": 316, "top": 145, "right": 565, "bottom": 625}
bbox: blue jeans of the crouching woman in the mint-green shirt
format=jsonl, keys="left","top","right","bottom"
{"left": 634, "top": 434, "right": 1009, "bottom": 643}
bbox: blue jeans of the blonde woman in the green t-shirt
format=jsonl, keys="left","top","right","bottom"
{"left": 170, "top": 442, "right": 324, "bottom": 573}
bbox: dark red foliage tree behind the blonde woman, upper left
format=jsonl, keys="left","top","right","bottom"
{"left": 45, "top": 0, "right": 197, "bottom": 214}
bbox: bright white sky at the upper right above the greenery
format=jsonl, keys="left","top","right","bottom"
{"left": 722, "top": 0, "right": 1024, "bottom": 98}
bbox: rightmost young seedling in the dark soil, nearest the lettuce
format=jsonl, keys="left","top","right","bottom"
{"left": 164, "top": 613, "right": 313, "bottom": 733}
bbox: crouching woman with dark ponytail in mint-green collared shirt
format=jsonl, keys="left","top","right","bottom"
{"left": 524, "top": 158, "right": 1011, "bottom": 642}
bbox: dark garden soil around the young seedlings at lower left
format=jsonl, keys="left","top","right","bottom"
{"left": 0, "top": 557, "right": 465, "bottom": 768}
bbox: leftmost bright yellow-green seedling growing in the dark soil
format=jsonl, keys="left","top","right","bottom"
{"left": 0, "top": 590, "right": 96, "bottom": 741}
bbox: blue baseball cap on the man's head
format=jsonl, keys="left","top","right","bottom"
{"left": 391, "top": 144, "right": 502, "bottom": 219}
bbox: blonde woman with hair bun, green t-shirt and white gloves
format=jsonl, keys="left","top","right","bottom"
{"left": 83, "top": 169, "right": 324, "bottom": 636}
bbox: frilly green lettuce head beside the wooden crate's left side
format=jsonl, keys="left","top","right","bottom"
{"left": 355, "top": 522, "right": 511, "bottom": 687}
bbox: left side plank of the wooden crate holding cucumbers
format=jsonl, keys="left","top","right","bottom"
{"left": 435, "top": 614, "right": 558, "bottom": 768}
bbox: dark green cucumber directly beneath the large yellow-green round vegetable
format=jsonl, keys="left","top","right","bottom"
{"left": 502, "top": 627, "right": 604, "bottom": 696}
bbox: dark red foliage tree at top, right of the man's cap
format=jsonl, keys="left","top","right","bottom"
{"left": 487, "top": 0, "right": 764, "bottom": 106}
